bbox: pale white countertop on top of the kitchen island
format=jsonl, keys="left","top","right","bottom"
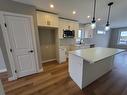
{"left": 69, "top": 47, "right": 125, "bottom": 64}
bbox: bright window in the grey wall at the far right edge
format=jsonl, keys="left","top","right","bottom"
{"left": 118, "top": 31, "right": 127, "bottom": 45}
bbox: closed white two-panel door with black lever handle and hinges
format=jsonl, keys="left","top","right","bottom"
{"left": 4, "top": 15, "right": 36, "bottom": 78}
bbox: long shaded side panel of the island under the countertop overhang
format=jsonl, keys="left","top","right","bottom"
{"left": 82, "top": 56, "right": 114, "bottom": 88}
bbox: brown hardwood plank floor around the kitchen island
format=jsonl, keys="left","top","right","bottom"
{"left": 2, "top": 52, "right": 127, "bottom": 95}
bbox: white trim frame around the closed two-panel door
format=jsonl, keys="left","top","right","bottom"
{"left": 0, "top": 11, "right": 40, "bottom": 81}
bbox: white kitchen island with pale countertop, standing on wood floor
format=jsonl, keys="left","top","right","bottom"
{"left": 69, "top": 47, "right": 124, "bottom": 89}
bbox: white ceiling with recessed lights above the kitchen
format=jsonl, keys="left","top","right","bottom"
{"left": 14, "top": 0, "right": 127, "bottom": 28}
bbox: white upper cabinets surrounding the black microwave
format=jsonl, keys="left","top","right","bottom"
{"left": 58, "top": 18, "right": 79, "bottom": 39}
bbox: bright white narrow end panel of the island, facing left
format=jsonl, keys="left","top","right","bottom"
{"left": 69, "top": 54, "right": 83, "bottom": 89}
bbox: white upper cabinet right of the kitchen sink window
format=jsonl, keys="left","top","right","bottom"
{"left": 85, "top": 24, "right": 94, "bottom": 38}
